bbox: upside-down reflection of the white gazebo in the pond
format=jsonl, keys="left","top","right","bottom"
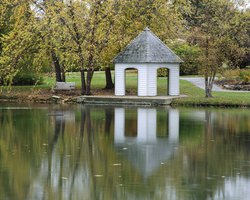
{"left": 114, "top": 108, "right": 179, "bottom": 178}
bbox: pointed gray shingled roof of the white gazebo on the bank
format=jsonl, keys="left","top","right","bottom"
{"left": 113, "top": 28, "right": 183, "bottom": 63}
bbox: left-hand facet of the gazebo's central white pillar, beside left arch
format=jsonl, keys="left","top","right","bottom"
{"left": 138, "top": 65, "right": 148, "bottom": 96}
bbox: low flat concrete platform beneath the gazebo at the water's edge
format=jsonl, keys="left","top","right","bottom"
{"left": 77, "top": 95, "right": 185, "bottom": 106}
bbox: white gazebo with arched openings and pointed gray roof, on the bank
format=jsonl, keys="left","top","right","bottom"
{"left": 113, "top": 28, "right": 183, "bottom": 96}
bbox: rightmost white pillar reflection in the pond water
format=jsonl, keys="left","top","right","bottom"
{"left": 168, "top": 109, "right": 180, "bottom": 143}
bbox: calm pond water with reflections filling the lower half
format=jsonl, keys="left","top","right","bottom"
{"left": 0, "top": 104, "right": 250, "bottom": 200}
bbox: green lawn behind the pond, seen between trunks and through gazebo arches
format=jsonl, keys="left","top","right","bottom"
{"left": 1, "top": 71, "right": 250, "bottom": 107}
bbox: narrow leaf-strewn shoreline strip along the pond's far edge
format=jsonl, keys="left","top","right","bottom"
{"left": 0, "top": 89, "right": 250, "bottom": 108}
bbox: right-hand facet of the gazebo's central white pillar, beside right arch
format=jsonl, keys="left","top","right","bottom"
{"left": 147, "top": 65, "right": 157, "bottom": 96}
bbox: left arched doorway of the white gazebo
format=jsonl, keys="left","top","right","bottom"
{"left": 125, "top": 68, "right": 138, "bottom": 96}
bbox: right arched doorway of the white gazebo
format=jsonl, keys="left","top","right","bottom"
{"left": 157, "top": 68, "right": 169, "bottom": 96}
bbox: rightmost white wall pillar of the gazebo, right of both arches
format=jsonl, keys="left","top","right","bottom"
{"left": 168, "top": 65, "right": 180, "bottom": 96}
